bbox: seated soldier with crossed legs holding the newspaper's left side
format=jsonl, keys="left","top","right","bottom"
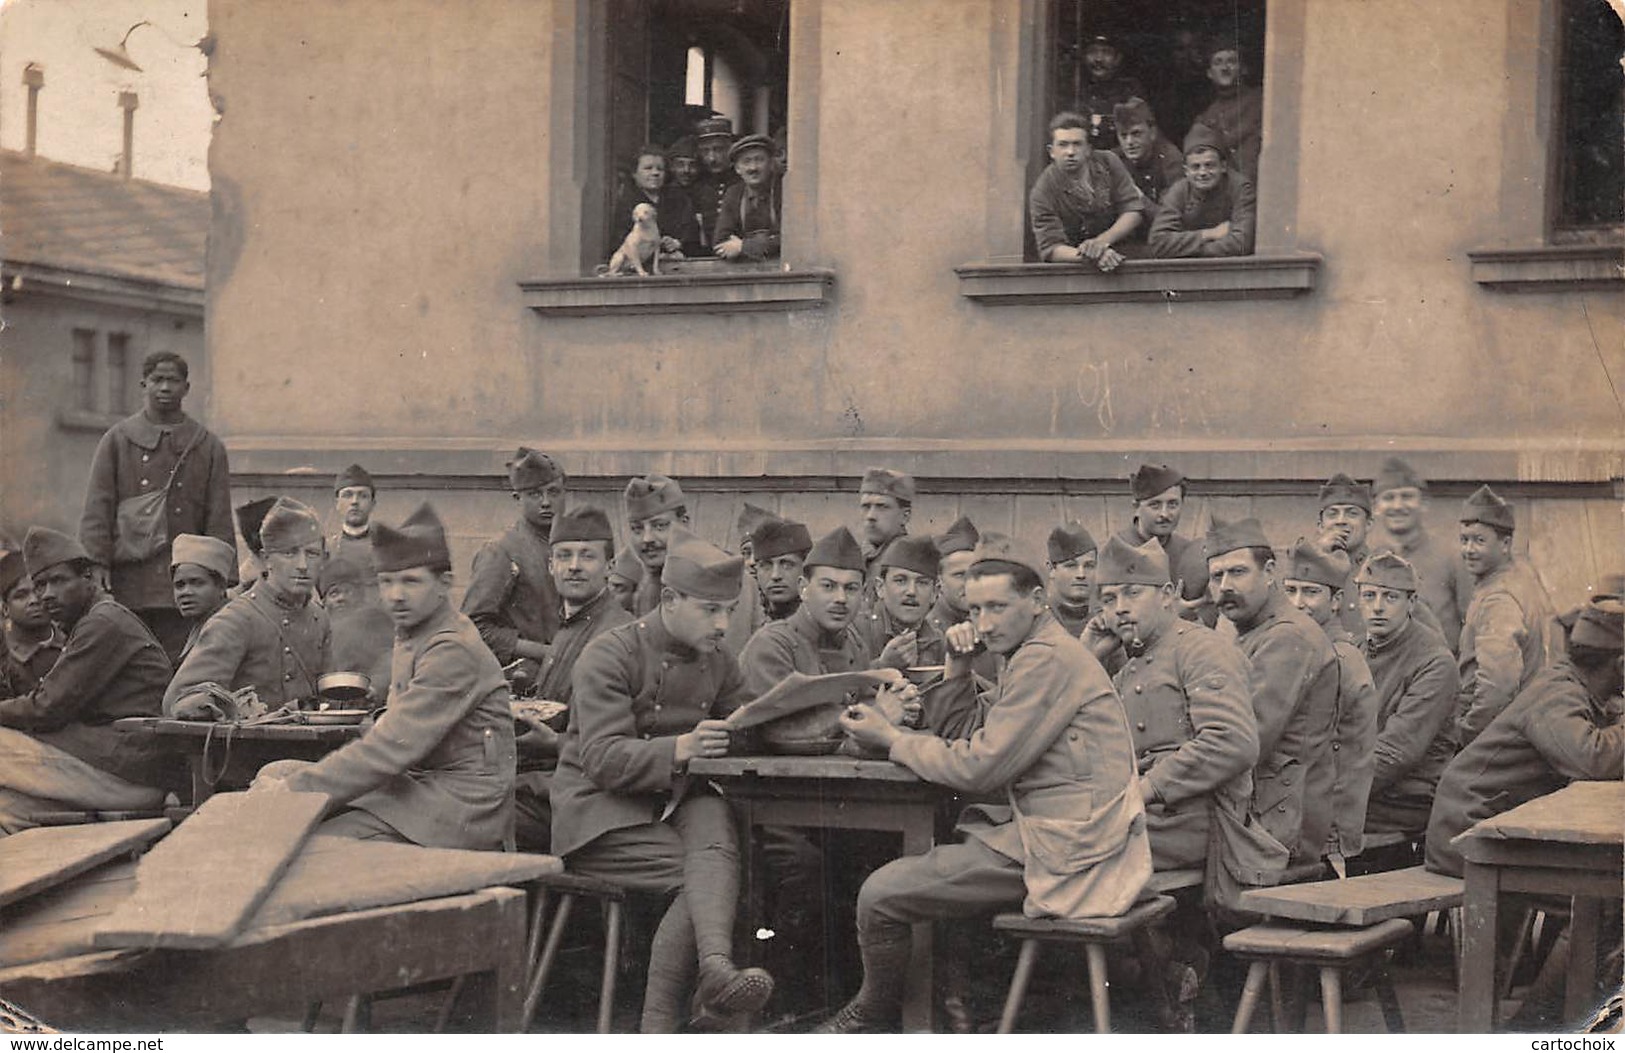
{"left": 553, "top": 530, "right": 774, "bottom": 1034}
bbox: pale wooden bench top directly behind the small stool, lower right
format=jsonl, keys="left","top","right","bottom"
{"left": 1242, "top": 866, "right": 1463, "bottom": 926}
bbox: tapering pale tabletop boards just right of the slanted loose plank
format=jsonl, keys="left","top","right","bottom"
{"left": 247, "top": 837, "right": 564, "bottom": 930}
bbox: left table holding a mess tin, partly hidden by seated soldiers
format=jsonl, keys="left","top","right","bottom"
{"left": 114, "top": 717, "right": 361, "bottom": 808}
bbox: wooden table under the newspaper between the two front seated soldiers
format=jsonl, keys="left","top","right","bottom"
{"left": 689, "top": 756, "right": 946, "bottom": 1032}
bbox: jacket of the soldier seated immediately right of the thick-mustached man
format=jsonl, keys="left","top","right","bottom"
{"left": 1303, "top": 624, "right": 1378, "bottom": 856}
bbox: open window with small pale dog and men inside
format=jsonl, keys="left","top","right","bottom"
{"left": 582, "top": 0, "right": 790, "bottom": 275}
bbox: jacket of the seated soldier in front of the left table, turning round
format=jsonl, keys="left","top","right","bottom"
{"left": 288, "top": 605, "right": 515, "bottom": 848}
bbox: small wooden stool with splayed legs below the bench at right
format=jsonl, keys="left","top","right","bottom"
{"left": 1224, "top": 918, "right": 1412, "bottom": 1035}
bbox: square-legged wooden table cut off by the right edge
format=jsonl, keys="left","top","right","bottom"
{"left": 1456, "top": 782, "right": 1625, "bottom": 1034}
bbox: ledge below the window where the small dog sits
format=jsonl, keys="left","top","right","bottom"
{"left": 518, "top": 260, "right": 835, "bottom": 315}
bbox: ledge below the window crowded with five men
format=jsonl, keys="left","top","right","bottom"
{"left": 954, "top": 252, "right": 1321, "bottom": 306}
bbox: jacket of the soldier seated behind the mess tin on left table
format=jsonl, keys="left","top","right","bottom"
{"left": 164, "top": 579, "right": 333, "bottom": 713}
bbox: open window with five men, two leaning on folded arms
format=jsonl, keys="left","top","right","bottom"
{"left": 1024, "top": 0, "right": 1266, "bottom": 261}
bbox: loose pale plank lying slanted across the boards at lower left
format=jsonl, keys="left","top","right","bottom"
{"left": 96, "top": 793, "right": 327, "bottom": 949}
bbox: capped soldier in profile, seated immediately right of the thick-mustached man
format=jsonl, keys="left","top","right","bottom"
{"left": 1282, "top": 538, "right": 1378, "bottom": 876}
